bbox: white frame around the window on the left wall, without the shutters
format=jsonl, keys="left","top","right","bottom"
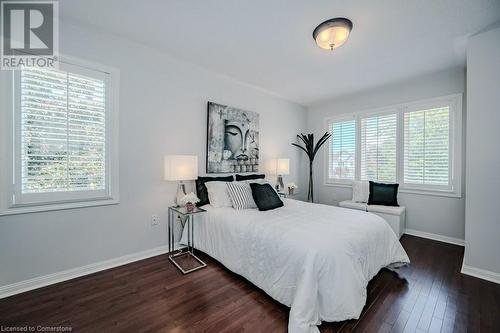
{"left": 0, "top": 56, "right": 119, "bottom": 215}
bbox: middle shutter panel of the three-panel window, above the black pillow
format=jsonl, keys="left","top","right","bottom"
{"left": 360, "top": 113, "right": 397, "bottom": 182}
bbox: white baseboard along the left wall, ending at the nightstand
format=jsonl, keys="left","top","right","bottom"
{"left": 0, "top": 245, "right": 182, "bottom": 299}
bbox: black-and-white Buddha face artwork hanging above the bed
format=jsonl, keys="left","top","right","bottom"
{"left": 207, "top": 102, "right": 259, "bottom": 173}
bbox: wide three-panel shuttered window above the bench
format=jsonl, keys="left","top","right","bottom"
{"left": 325, "top": 94, "right": 462, "bottom": 196}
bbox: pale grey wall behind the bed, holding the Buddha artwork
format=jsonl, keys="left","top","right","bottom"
{"left": 0, "top": 22, "right": 307, "bottom": 286}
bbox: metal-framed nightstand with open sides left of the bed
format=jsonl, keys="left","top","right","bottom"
{"left": 168, "top": 206, "right": 207, "bottom": 274}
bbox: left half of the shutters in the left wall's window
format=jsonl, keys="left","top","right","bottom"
{"left": 20, "top": 70, "right": 68, "bottom": 193}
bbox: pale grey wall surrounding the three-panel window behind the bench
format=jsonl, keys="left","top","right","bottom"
{"left": 308, "top": 68, "right": 465, "bottom": 240}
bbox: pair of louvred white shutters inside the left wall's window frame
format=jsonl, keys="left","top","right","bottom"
{"left": 18, "top": 69, "right": 106, "bottom": 194}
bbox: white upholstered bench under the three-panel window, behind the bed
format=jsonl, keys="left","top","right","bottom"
{"left": 339, "top": 200, "right": 406, "bottom": 238}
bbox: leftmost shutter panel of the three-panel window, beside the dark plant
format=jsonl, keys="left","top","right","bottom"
{"left": 328, "top": 119, "right": 356, "bottom": 179}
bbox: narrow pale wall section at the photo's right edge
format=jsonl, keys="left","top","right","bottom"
{"left": 464, "top": 28, "right": 500, "bottom": 274}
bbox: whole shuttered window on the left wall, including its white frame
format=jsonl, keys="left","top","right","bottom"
{"left": 0, "top": 57, "right": 118, "bottom": 212}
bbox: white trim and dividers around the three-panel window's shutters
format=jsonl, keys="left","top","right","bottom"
{"left": 324, "top": 94, "right": 463, "bottom": 197}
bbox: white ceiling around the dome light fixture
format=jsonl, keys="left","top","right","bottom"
{"left": 60, "top": 0, "right": 500, "bottom": 105}
